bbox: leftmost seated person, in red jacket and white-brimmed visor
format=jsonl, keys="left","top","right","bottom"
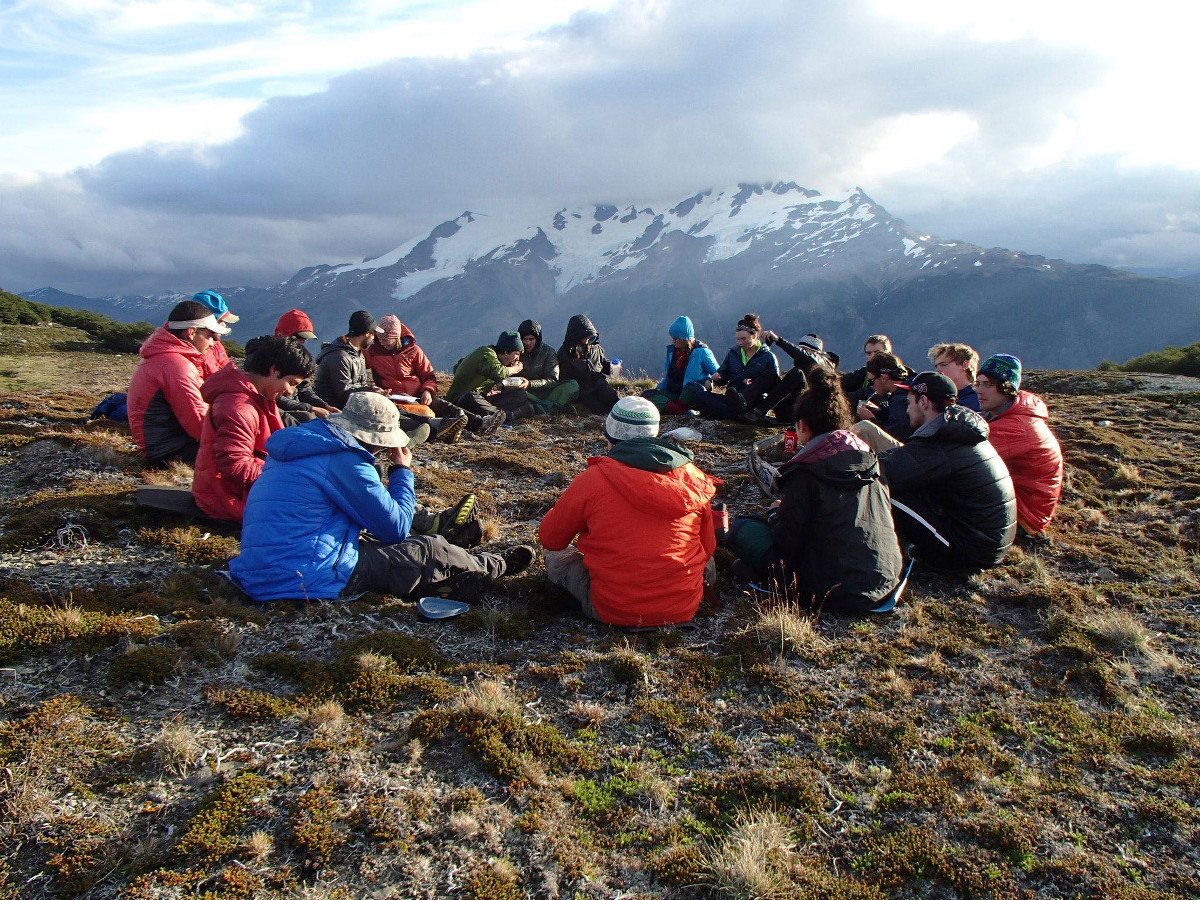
{"left": 127, "top": 300, "right": 229, "bottom": 466}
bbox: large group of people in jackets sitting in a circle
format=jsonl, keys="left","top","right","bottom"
{"left": 119, "top": 292, "right": 1062, "bottom": 626}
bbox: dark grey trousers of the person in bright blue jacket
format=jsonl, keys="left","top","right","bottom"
{"left": 342, "top": 534, "right": 506, "bottom": 595}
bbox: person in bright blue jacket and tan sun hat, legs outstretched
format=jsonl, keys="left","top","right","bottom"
{"left": 229, "top": 391, "right": 534, "bottom": 601}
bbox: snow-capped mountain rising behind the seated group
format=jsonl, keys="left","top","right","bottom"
{"left": 23, "top": 182, "right": 1200, "bottom": 373}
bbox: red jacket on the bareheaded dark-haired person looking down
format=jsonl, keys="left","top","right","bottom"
{"left": 192, "top": 366, "right": 283, "bottom": 522}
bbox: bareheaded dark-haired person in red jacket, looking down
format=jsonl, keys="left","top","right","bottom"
{"left": 192, "top": 337, "right": 316, "bottom": 522}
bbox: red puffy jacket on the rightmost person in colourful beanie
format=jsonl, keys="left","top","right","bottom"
{"left": 988, "top": 391, "right": 1062, "bottom": 534}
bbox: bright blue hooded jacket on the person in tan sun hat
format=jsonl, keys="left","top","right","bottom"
{"left": 229, "top": 419, "right": 415, "bottom": 601}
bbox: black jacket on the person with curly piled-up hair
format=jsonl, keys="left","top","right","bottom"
{"left": 768, "top": 431, "right": 902, "bottom": 612}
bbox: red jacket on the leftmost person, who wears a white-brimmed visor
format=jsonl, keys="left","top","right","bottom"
{"left": 127, "top": 325, "right": 209, "bottom": 461}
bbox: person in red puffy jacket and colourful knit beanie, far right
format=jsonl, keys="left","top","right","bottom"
{"left": 976, "top": 353, "right": 1062, "bottom": 534}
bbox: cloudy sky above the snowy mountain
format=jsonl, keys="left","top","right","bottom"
{"left": 0, "top": 0, "right": 1200, "bottom": 296}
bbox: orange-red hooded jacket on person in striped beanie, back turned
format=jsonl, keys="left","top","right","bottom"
{"left": 538, "top": 438, "right": 720, "bottom": 626}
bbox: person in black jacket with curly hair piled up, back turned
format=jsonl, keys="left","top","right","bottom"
{"left": 730, "top": 368, "right": 902, "bottom": 612}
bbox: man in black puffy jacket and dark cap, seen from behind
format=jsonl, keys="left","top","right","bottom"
{"left": 880, "top": 372, "right": 1016, "bottom": 570}
